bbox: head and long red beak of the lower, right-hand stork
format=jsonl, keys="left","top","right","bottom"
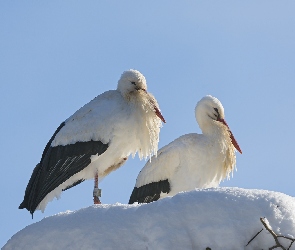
{"left": 195, "top": 95, "right": 242, "bottom": 153}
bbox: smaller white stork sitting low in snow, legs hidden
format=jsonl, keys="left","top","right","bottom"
{"left": 129, "top": 95, "right": 242, "bottom": 204}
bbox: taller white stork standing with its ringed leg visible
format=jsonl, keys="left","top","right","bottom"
{"left": 19, "top": 70, "right": 165, "bottom": 215}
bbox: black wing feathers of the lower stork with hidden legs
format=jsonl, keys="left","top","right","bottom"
{"left": 128, "top": 179, "right": 171, "bottom": 204}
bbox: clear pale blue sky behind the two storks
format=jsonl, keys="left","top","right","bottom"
{"left": 0, "top": 0, "right": 295, "bottom": 247}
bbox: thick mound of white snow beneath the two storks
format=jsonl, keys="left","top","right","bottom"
{"left": 2, "top": 188, "right": 295, "bottom": 250}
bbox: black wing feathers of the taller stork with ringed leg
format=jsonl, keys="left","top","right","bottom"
{"left": 19, "top": 123, "right": 108, "bottom": 214}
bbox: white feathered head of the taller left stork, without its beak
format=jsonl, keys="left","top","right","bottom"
{"left": 117, "top": 69, "right": 147, "bottom": 97}
